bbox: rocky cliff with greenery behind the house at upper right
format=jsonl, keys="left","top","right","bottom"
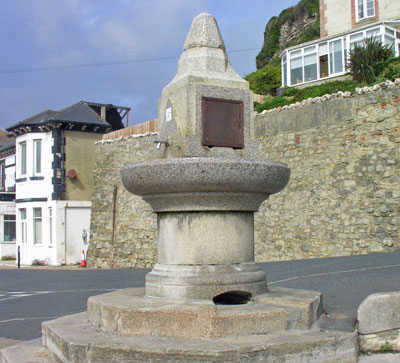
{"left": 256, "top": 0, "right": 320, "bottom": 69}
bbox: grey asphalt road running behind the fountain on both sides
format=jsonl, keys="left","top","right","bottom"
{"left": 0, "top": 252, "right": 400, "bottom": 340}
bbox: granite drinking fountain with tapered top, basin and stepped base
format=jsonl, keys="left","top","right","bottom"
{"left": 1, "top": 14, "right": 356, "bottom": 363}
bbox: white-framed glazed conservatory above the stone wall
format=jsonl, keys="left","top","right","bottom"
{"left": 280, "top": 21, "right": 400, "bottom": 87}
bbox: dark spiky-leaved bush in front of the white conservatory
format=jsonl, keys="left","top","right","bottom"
{"left": 349, "top": 37, "right": 393, "bottom": 83}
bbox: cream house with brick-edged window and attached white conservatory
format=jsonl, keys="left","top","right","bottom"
{"left": 280, "top": 0, "right": 400, "bottom": 87}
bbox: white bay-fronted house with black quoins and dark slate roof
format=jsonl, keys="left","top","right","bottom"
{"left": 7, "top": 101, "right": 130, "bottom": 265}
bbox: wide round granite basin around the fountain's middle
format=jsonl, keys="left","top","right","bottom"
{"left": 121, "top": 157, "right": 290, "bottom": 212}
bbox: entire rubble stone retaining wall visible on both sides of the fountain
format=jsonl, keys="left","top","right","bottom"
{"left": 88, "top": 84, "right": 400, "bottom": 267}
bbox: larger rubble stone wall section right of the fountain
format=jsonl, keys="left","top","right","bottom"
{"left": 255, "top": 83, "right": 400, "bottom": 261}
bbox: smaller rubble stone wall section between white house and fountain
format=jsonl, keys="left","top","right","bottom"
{"left": 87, "top": 133, "right": 157, "bottom": 268}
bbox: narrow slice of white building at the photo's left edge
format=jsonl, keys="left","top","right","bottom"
{"left": 0, "top": 135, "right": 16, "bottom": 258}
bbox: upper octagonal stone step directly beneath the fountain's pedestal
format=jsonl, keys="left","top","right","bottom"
{"left": 88, "top": 288, "right": 322, "bottom": 338}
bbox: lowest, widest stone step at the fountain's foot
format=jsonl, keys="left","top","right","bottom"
{"left": 40, "top": 313, "right": 358, "bottom": 363}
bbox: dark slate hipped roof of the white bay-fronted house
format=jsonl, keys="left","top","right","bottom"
{"left": 6, "top": 101, "right": 119, "bottom": 131}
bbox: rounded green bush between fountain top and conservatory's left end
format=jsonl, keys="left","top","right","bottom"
{"left": 245, "top": 64, "right": 282, "bottom": 96}
